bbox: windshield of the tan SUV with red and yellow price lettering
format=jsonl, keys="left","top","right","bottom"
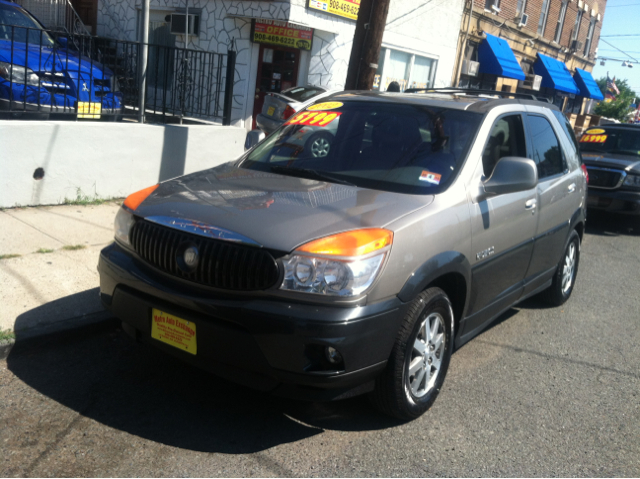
{"left": 240, "top": 101, "right": 482, "bottom": 194}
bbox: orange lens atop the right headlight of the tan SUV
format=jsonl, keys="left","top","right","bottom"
{"left": 296, "top": 228, "right": 393, "bottom": 256}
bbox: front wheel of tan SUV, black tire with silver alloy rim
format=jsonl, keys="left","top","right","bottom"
{"left": 370, "top": 288, "right": 454, "bottom": 421}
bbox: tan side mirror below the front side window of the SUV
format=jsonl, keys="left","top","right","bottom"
{"left": 484, "top": 156, "right": 538, "bottom": 195}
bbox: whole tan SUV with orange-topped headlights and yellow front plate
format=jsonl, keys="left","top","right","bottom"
{"left": 99, "top": 90, "right": 586, "bottom": 420}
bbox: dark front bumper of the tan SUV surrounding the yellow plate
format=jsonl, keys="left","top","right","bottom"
{"left": 98, "top": 243, "right": 408, "bottom": 400}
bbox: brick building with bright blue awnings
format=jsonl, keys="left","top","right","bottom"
{"left": 452, "top": 0, "right": 606, "bottom": 128}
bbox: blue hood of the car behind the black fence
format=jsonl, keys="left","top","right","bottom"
{"left": 0, "top": 40, "right": 113, "bottom": 80}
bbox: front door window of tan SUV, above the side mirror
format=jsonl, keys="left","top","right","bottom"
{"left": 482, "top": 115, "right": 527, "bottom": 178}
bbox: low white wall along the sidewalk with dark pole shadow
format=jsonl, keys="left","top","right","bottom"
{"left": 0, "top": 121, "right": 246, "bottom": 208}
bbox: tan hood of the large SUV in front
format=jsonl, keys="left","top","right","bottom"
{"left": 135, "top": 163, "right": 433, "bottom": 251}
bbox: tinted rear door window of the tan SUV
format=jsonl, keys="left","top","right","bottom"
{"left": 529, "top": 115, "right": 564, "bottom": 179}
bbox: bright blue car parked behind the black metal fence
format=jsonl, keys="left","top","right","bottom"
{"left": 0, "top": 0, "right": 123, "bottom": 119}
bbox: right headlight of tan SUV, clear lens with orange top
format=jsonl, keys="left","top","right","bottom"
{"left": 280, "top": 228, "right": 393, "bottom": 297}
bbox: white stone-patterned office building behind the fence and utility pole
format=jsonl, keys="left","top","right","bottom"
{"left": 96, "top": 0, "right": 465, "bottom": 129}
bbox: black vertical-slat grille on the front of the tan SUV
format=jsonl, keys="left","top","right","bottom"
{"left": 130, "top": 220, "right": 278, "bottom": 291}
